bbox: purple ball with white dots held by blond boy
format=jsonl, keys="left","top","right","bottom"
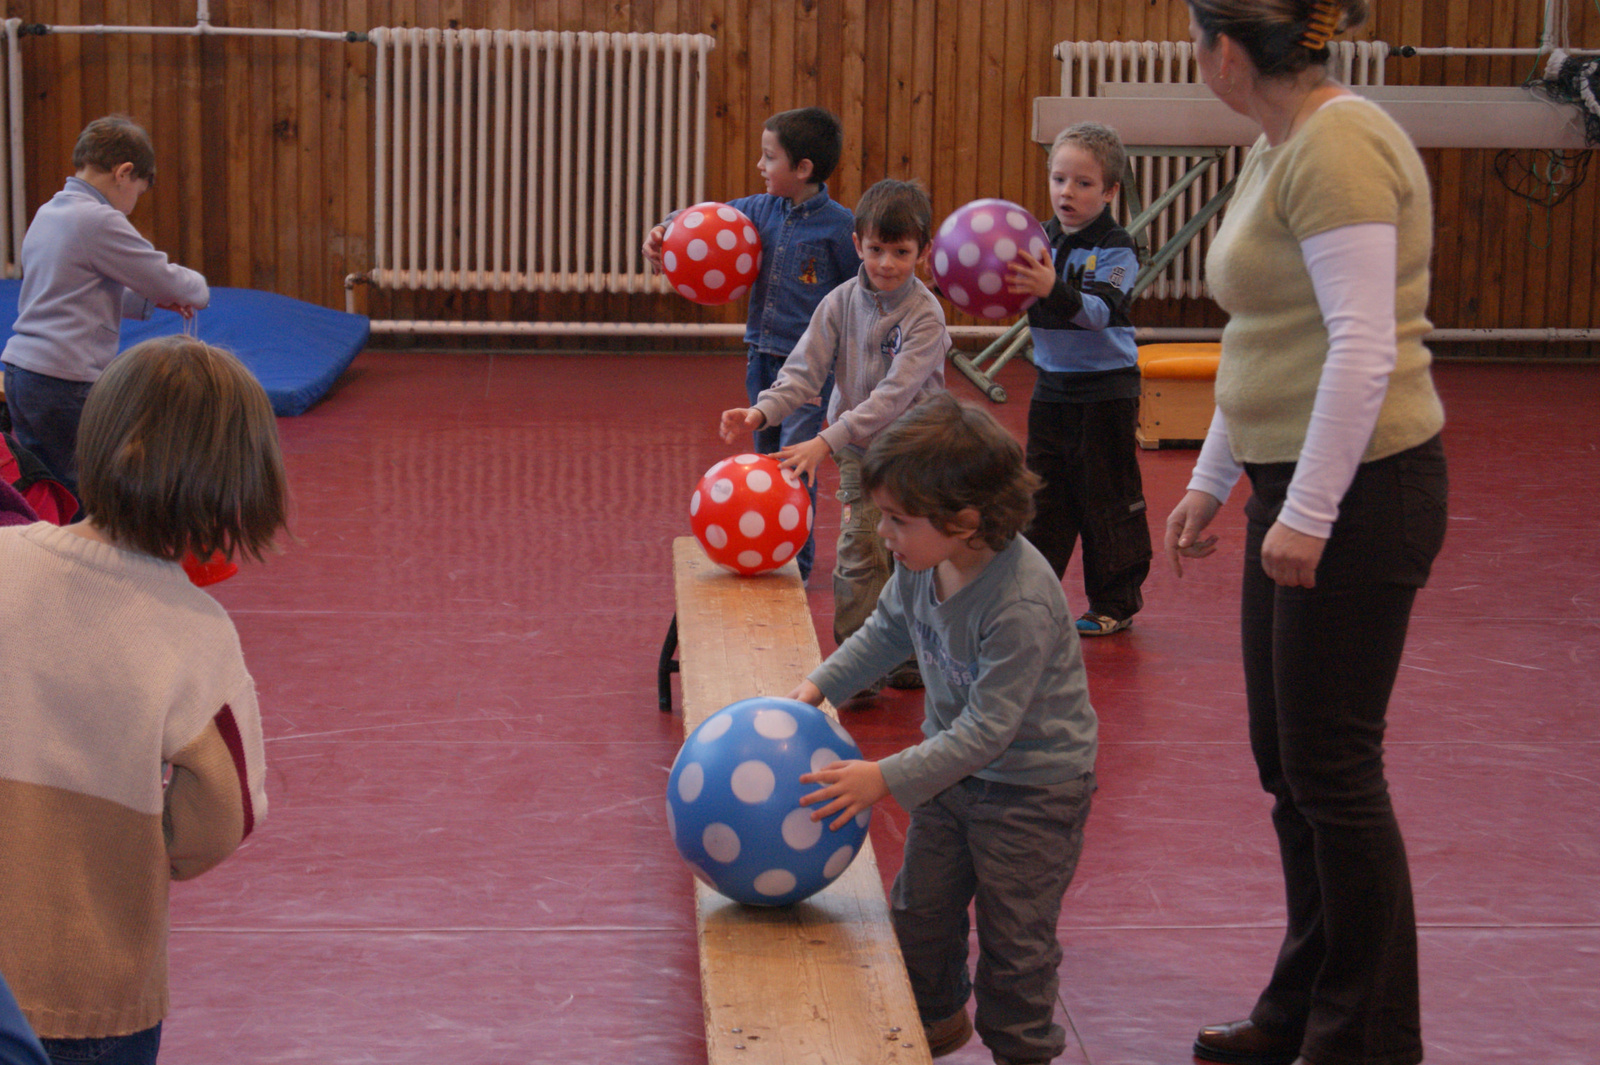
{"left": 930, "top": 200, "right": 1050, "bottom": 318}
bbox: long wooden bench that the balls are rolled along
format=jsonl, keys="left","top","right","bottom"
{"left": 672, "top": 536, "right": 933, "bottom": 1065}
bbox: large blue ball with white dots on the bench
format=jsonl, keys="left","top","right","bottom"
{"left": 667, "top": 697, "right": 872, "bottom": 907}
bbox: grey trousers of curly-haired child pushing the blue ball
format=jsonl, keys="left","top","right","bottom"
{"left": 890, "top": 772, "right": 1094, "bottom": 1062}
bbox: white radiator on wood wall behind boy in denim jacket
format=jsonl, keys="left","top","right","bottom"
{"left": 357, "top": 29, "right": 715, "bottom": 326}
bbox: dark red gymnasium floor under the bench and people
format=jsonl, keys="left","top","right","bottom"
{"left": 162, "top": 353, "right": 1600, "bottom": 1065}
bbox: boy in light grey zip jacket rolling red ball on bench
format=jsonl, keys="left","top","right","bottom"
{"left": 722, "top": 179, "right": 950, "bottom": 688}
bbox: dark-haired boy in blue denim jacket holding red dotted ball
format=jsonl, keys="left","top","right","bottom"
{"left": 645, "top": 107, "right": 861, "bottom": 580}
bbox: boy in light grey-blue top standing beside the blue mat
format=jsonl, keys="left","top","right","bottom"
{"left": 0, "top": 115, "right": 211, "bottom": 494}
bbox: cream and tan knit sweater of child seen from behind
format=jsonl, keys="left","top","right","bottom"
{"left": 0, "top": 523, "right": 267, "bottom": 1038}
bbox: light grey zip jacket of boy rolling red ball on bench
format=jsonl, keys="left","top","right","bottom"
{"left": 755, "top": 267, "right": 950, "bottom": 451}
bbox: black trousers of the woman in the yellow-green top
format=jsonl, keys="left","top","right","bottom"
{"left": 1242, "top": 437, "right": 1446, "bottom": 1065}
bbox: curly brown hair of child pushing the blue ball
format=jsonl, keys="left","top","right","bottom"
{"left": 861, "top": 392, "right": 1040, "bottom": 550}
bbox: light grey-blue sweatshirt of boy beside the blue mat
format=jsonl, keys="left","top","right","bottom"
{"left": 5, "top": 178, "right": 211, "bottom": 381}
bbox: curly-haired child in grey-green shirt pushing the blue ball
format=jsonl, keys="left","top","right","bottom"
{"left": 792, "top": 393, "right": 1096, "bottom": 1065}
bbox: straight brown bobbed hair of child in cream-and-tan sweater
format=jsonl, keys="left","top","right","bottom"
{"left": 78, "top": 336, "right": 288, "bottom": 561}
